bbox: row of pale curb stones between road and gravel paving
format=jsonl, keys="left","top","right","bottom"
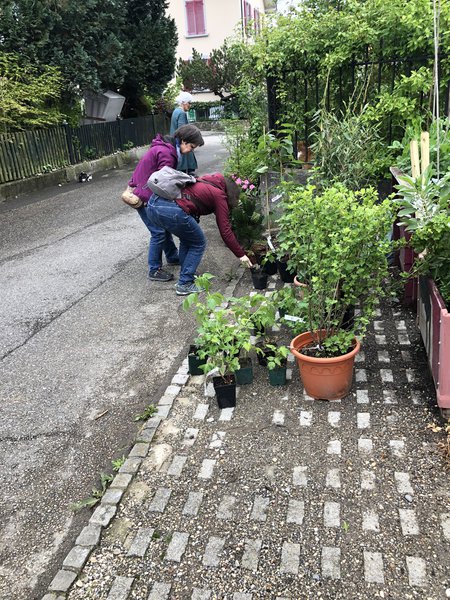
{"left": 42, "top": 271, "right": 244, "bottom": 600}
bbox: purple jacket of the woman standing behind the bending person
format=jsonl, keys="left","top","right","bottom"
{"left": 128, "top": 133, "right": 178, "bottom": 204}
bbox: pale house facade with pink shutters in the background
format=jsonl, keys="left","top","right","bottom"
{"left": 167, "top": 0, "right": 276, "bottom": 102}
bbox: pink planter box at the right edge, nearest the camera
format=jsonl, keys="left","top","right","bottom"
{"left": 417, "top": 277, "right": 450, "bottom": 410}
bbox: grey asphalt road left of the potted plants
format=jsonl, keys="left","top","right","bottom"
{"left": 0, "top": 134, "right": 239, "bottom": 600}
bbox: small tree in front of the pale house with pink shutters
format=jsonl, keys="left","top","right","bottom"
{"left": 177, "top": 40, "right": 245, "bottom": 102}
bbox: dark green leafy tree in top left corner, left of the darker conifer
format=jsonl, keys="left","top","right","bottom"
{"left": 0, "top": 0, "right": 124, "bottom": 103}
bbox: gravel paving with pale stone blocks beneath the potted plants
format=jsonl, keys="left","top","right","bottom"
{"left": 46, "top": 279, "right": 450, "bottom": 600}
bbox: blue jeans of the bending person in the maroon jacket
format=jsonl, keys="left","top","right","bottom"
{"left": 147, "top": 194, "right": 206, "bottom": 285}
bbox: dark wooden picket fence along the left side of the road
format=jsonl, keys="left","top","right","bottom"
{"left": 0, "top": 115, "right": 169, "bottom": 184}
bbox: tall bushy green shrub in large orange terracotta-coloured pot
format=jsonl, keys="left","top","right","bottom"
{"left": 278, "top": 184, "right": 393, "bottom": 400}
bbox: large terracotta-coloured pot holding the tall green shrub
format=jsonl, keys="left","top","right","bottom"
{"left": 290, "top": 331, "right": 361, "bottom": 400}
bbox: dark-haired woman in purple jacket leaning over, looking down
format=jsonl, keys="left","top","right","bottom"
{"left": 128, "top": 125, "right": 204, "bottom": 281}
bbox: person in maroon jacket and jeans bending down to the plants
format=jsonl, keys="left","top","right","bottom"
{"left": 147, "top": 173, "right": 252, "bottom": 296}
